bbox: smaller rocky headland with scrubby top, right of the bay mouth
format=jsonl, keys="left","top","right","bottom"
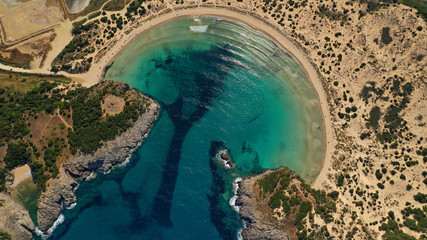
{"left": 236, "top": 167, "right": 338, "bottom": 240}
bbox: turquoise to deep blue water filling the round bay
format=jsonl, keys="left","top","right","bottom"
{"left": 53, "top": 18, "right": 323, "bottom": 240}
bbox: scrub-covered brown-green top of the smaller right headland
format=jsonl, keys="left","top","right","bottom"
{"left": 254, "top": 167, "right": 339, "bottom": 239}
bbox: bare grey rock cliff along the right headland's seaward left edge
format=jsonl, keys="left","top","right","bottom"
{"left": 236, "top": 174, "right": 290, "bottom": 240}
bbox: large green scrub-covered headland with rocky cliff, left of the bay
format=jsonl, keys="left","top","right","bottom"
{"left": 0, "top": 72, "right": 159, "bottom": 239}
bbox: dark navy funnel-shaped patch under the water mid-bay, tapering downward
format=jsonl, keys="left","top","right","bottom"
{"left": 151, "top": 47, "right": 235, "bottom": 226}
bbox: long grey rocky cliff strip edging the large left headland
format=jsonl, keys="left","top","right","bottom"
{"left": 37, "top": 97, "right": 159, "bottom": 233}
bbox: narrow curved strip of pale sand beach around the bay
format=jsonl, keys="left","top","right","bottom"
{"left": 91, "top": 7, "right": 335, "bottom": 186}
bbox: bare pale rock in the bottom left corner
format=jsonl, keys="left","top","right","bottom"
{"left": 0, "top": 193, "right": 34, "bottom": 240}
